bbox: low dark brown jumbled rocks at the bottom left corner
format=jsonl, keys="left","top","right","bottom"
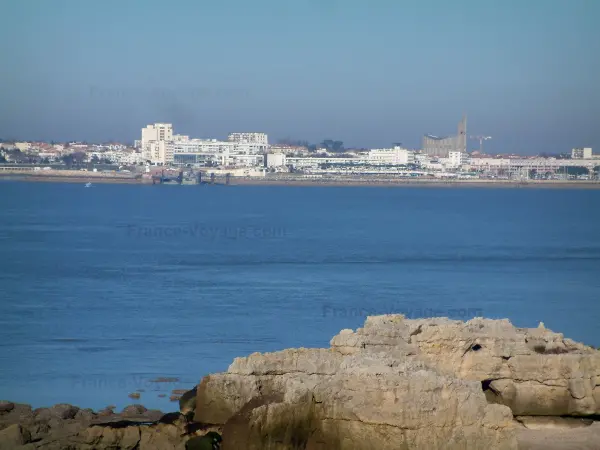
{"left": 0, "top": 402, "right": 218, "bottom": 450}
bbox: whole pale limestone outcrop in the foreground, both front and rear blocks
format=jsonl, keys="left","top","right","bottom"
{"left": 195, "top": 315, "right": 600, "bottom": 450}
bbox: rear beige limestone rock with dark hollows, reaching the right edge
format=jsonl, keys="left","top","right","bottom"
{"left": 331, "top": 316, "right": 600, "bottom": 416}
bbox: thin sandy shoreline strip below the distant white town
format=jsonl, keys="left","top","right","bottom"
{"left": 0, "top": 173, "right": 600, "bottom": 189}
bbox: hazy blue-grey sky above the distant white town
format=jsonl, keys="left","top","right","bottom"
{"left": 0, "top": 0, "right": 600, "bottom": 154}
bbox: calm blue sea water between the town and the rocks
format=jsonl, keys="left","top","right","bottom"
{"left": 0, "top": 182, "right": 600, "bottom": 410}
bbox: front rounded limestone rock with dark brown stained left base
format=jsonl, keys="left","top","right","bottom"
{"left": 196, "top": 349, "right": 516, "bottom": 450}
